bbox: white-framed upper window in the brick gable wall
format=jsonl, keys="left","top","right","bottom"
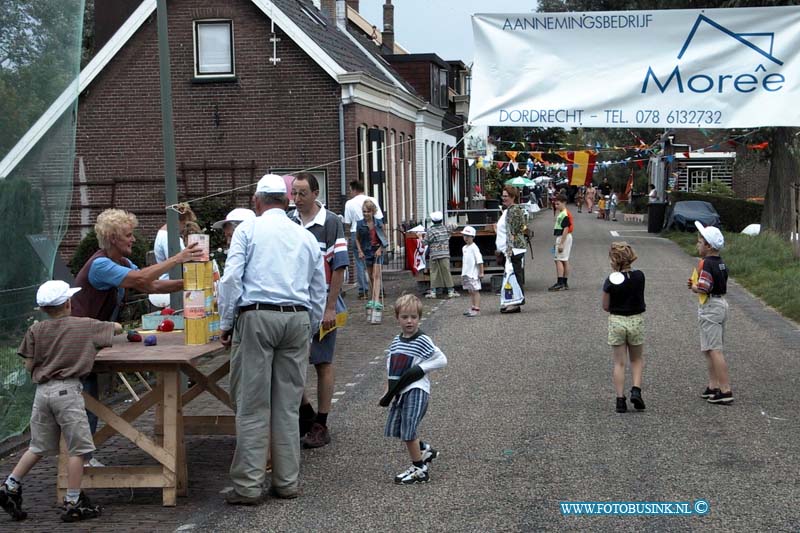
{"left": 194, "top": 20, "right": 235, "bottom": 78}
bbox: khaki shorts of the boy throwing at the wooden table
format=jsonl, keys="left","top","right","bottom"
{"left": 30, "top": 378, "right": 95, "bottom": 457}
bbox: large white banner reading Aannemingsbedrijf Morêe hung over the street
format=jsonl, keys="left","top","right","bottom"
{"left": 469, "top": 6, "right": 800, "bottom": 128}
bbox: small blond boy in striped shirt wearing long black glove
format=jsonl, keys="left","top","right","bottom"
{"left": 379, "top": 294, "right": 447, "bottom": 485}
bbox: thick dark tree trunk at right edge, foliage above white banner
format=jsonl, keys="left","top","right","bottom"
{"left": 537, "top": 0, "right": 799, "bottom": 236}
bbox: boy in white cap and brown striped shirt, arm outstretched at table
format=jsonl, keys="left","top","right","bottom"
{"left": 0, "top": 280, "right": 122, "bottom": 522}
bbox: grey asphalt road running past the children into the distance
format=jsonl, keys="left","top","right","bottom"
{"left": 194, "top": 212, "right": 800, "bottom": 531}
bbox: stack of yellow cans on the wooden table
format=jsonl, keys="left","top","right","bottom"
{"left": 183, "top": 235, "right": 219, "bottom": 344}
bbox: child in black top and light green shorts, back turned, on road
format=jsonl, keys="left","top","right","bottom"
{"left": 603, "top": 242, "right": 645, "bottom": 413}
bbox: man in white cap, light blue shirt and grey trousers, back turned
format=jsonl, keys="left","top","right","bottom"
{"left": 219, "top": 174, "right": 326, "bottom": 505}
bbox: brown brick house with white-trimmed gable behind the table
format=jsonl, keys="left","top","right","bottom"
{"left": 0, "top": 0, "right": 472, "bottom": 258}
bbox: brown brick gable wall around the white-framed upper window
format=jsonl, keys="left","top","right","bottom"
{"left": 61, "top": 0, "right": 344, "bottom": 258}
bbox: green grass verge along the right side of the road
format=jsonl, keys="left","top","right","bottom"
{"left": 662, "top": 231, "right": 800, "bottom": 322}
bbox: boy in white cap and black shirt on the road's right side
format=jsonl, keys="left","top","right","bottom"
{"left": 688, "top": 221, "right": 733, "bottom": 404}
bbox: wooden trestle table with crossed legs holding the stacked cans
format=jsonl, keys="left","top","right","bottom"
{"left": 57, "top": 331, "right": 231, "bottom": 506}
